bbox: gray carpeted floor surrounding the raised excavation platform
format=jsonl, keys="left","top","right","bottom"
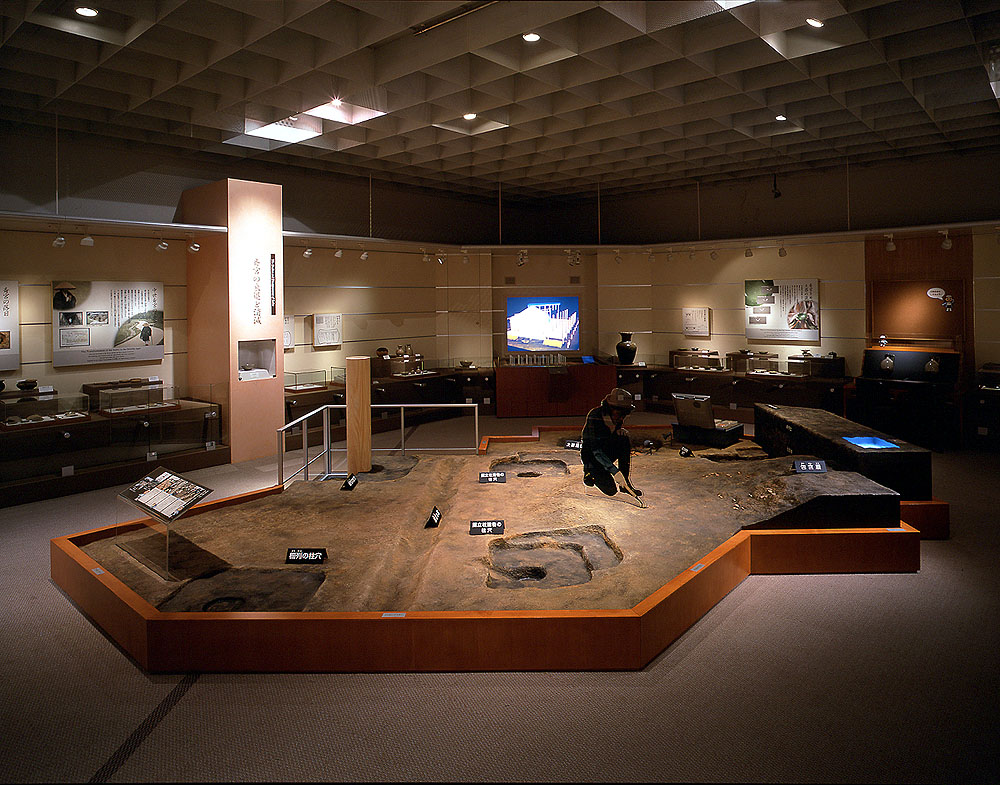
{"left": 0, "top": 418, "right": 1000, "bottom": 783}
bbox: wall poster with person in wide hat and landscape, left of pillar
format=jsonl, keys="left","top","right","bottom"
{"left": 52, "top": 281, "right": 163, "bottom": 367}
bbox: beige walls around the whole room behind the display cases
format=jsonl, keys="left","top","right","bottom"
{"left": 0, "top": 231, "right": 1000, "bottom": 392}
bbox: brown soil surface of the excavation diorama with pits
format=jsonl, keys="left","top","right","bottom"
{"left": 84, "top": 432, "right": 899, "bottom": 611}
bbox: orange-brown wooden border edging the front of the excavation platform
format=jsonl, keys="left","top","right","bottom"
{"left": 50, "top": 496, "right": 920, "bottom": 673}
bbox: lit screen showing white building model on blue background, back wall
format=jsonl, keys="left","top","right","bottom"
{"left": 507, "top": 296, "right": 580, "bottom": 352}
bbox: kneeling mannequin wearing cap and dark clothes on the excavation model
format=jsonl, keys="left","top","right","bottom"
{"left": 580, "top": 387, "right": 646, "bottom": 507}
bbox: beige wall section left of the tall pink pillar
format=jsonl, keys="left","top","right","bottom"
{"left": 0, "top": 231, "right": 188, "bottom": 393}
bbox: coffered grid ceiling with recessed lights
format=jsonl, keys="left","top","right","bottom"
{"left": 0, "top": 0, "right": 1000, "bottom": 197}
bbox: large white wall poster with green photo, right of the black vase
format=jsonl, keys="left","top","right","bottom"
{"left": 744, "top": 278, "right": 819, "bottom": 341}
